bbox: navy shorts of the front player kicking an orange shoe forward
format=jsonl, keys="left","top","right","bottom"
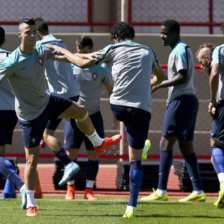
{"left": 19, "top": 95, "right": 72, "bottom": 148}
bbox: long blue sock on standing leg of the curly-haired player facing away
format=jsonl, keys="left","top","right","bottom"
{"left": 128, "top": 161, "right": 143, "bottom": 208}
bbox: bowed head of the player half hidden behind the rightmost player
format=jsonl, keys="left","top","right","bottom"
{"left": 195, "top": 43, "right": 215, "bottom": 74}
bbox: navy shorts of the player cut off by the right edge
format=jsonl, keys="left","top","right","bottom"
{"left": 211, "top": 100, "right": 224, "bottom": 144}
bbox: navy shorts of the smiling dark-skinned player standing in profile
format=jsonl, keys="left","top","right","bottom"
{"left": 162, "top": 95, "right": 199, "bottom": 140}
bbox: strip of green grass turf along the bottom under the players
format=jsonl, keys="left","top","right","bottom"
{"left": 0, "top": 197, "right": 224, "bottom": 224}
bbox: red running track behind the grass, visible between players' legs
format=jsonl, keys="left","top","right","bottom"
{"left": 1, "top": 164, "right": 218, "bottom": 198}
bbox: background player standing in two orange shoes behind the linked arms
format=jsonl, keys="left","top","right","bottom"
{"left": 64, "top": 36, "right": 113, "bottom": 200}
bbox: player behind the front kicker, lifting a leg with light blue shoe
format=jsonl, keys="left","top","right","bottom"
{"left": 34, "top": 18, "right": 79, "bottom": 186}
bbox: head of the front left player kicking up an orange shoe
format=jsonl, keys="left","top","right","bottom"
{"left": 18, "top": 18, "right": 37, "bottom": 47}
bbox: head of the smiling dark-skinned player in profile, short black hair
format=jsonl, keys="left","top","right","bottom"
{"left": 160, "top": 20, "right": 180, "bottom": 47}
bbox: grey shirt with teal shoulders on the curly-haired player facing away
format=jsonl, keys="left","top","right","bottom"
{"left": 102, "top": 41, "right": 155, "bottom": 111}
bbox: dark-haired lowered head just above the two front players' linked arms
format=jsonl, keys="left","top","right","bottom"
{"left": 75, "top": 35, "right": 93, "bottom": 54}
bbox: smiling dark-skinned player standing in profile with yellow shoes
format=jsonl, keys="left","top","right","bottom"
{"left": 141, "top": 20, "right": 206, "bottom": 202}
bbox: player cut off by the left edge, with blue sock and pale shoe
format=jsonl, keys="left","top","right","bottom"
{"left": 0, "top": 27, "right": 26, "bottom": 208}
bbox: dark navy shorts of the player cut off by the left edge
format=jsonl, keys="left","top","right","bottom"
{"left": 0, "top": 110, "right": 18, "bottom": 146}
